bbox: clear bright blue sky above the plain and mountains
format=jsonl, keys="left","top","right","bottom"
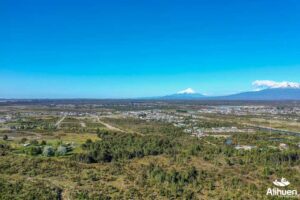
{"left": 0, "top": 0, "right": 300, "bottom": 98}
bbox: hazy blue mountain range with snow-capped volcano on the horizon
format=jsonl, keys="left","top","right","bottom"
{"left": 158, "top": 88, "right": 300, "bottom": 101}
